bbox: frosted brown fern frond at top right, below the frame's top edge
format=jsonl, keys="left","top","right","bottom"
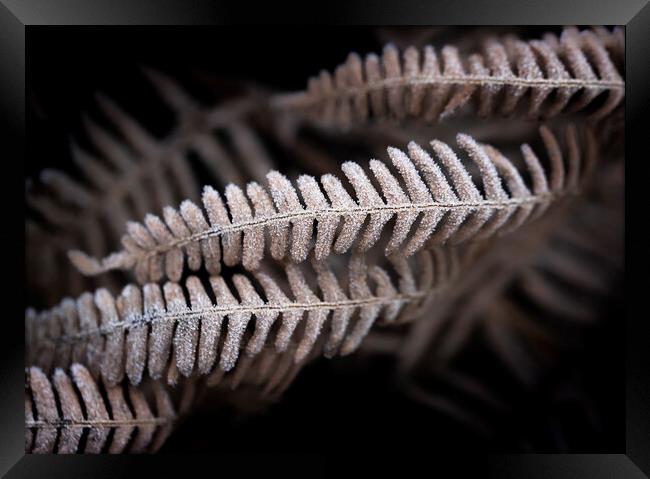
{"left": 271, "top": 28, "right": 625, "bottom": 128}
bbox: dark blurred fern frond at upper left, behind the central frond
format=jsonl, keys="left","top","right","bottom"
{"left": 27, "top": 78, "right": 272, "bottom": 251}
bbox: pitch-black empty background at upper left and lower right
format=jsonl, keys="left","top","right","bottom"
{"left": 25, "top": 26, "right": 625, "bottom": 452}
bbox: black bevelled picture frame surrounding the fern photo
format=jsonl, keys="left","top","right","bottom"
{"left": 0, "top": 0, "right": 650, "bottom": 478}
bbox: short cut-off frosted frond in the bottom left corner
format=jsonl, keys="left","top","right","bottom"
{"left": 25, "top": 363, "right": 185, "bottom": 454}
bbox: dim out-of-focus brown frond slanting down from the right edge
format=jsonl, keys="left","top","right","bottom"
{"left": 400, "top": 158, "right": 623, "bottom": 382}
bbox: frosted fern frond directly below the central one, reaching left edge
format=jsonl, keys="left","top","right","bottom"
{"left": 26, "top": 249, "right": 459, "bottom": 385}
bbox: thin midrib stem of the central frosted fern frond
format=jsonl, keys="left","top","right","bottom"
{"left": 138, "top": 192, "right": 572, "bottom": 261}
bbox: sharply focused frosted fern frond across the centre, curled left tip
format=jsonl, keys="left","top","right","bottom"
{"left": 70, "top": 126, "right": 596, "bottom": 283}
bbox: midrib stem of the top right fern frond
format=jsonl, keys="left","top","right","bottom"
{"left": 271, "top": 75, "right": 625, "bottom": 107}
